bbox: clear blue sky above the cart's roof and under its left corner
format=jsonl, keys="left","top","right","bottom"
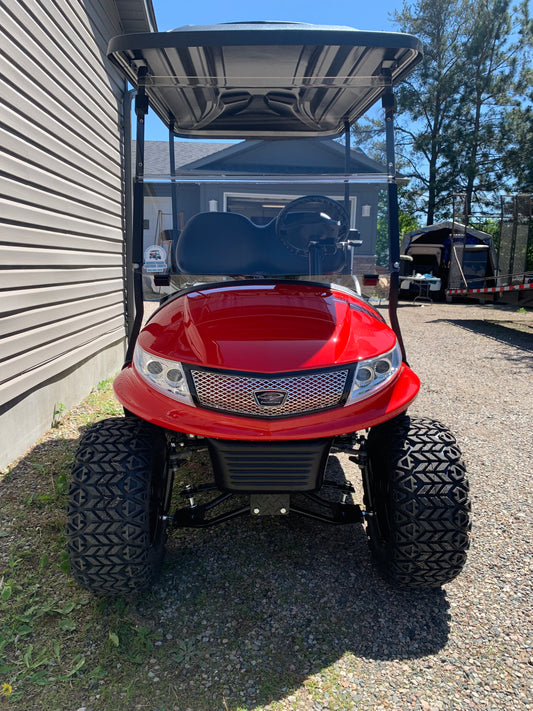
{"left": 146, "top": 0, "right": 402, "bottom": 141}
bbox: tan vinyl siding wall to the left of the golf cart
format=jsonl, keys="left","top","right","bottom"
{"left": 0, "top": 0, "right": 129, "bottom": 467}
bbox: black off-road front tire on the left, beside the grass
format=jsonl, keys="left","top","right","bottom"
{"left": 67, "top": 417, "right": 171, "bottom": 596}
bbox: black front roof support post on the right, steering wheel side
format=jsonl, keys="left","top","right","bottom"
{"left": 382, "top": 86, "right": 406, "bottom": 361}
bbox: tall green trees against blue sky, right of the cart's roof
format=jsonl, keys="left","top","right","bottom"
{"left": 353, "top": 0, "right": 533, "bottom": 224}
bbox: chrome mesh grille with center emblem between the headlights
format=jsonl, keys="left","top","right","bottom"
{"left": 191, "top": 369, "right": 349, "bottom": 417}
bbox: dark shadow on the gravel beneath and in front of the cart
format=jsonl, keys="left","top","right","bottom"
{"left": 137, "top": 458, "right": 450, "bottom": 711}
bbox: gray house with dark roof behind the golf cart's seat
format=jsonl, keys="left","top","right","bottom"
{"left": 139, "top": 139, "right": 385, "bottom": 272}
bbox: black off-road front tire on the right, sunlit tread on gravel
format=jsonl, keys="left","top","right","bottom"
{"left": 363, "top": 415, "right": 470, "bottom": 588}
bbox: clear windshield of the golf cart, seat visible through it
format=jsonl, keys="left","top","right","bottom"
{"left": 139, "top": 139, "right": 388, "bottom": 299}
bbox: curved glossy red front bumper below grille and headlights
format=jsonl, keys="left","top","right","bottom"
{"left": 114, "top": 364, "right": 420, "bottom": 441}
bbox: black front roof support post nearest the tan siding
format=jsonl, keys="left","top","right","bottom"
{"left": 125, "top": 66, "right": 148, "bottom": 365}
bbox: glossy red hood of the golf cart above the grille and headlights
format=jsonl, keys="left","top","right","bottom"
{"left": 139, "top": 282, "right": 396, "bottom": 373}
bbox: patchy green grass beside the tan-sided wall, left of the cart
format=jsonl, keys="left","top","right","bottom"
{"left": 0, "top": 382, "right": 154, "bottom": 709}
